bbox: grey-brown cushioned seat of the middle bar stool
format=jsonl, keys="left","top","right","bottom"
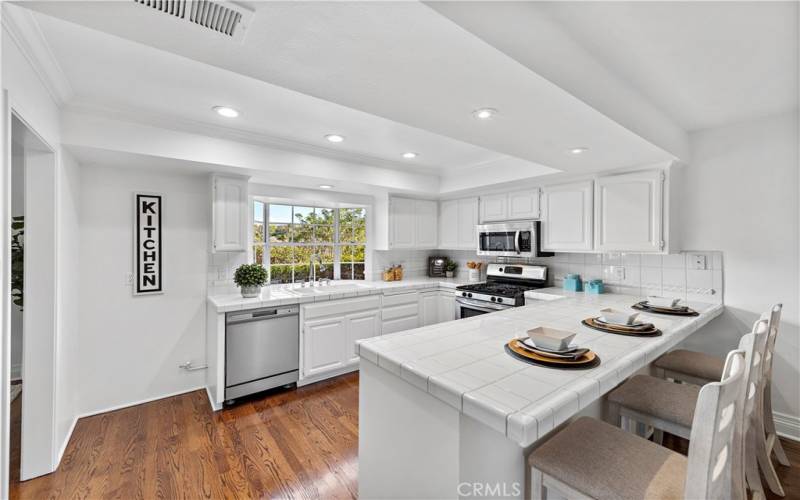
{"left": 608, "top": 375, "right": 700, "bottom": 428}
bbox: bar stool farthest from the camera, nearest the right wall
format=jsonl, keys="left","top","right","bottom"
{"left": 653, "top": 304, "right": 790, "bottom": 496}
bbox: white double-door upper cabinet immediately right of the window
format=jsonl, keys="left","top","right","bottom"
{"left": 388, "top": 197, "right": 439, "bottom": 248}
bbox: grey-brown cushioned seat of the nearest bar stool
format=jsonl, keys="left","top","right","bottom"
{"left": 528, "top": 417, "right": 687, "bottom": 499}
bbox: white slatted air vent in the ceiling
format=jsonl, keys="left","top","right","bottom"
{"left": 133, "top": 0, "right": 253, "bottom": 42}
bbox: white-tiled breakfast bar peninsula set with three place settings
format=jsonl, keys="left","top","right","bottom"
{"left": 356, "top": 288, "right": 723, "bottom": 498}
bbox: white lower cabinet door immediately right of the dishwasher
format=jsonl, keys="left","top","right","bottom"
{"left": 303, "top": 316, "right": 348, "bottom": 377}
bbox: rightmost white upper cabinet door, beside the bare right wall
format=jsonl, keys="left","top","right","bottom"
{"left": 594, "top": 170, "right": 666, "bottom": 252}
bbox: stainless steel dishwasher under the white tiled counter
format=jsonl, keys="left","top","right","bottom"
{"left": 225, "top": 306, "right": 300, "bottom": 402}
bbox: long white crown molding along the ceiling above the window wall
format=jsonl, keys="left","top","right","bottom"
{"left": 64, "top": 100, "right": 450, "bottom": 178}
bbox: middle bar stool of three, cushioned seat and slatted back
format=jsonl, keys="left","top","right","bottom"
{"left": 608, "top": 320, "right": 769, "bottom": 498}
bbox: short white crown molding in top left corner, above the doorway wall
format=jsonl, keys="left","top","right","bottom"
{"left": 2, "top": 2, "right": 74, "bottom": 107}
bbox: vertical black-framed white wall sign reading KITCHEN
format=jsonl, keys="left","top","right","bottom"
{"left": 133, "top": 193, "right": 163, "bottom": 295}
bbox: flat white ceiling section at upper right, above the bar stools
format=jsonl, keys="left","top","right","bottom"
{"left": 535, "top": 1, "right": 800, "bottom": 131}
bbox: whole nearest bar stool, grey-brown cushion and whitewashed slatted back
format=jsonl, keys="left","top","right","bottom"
{"left": 528, "top": 350, "right": 745, "bottom": 500}
